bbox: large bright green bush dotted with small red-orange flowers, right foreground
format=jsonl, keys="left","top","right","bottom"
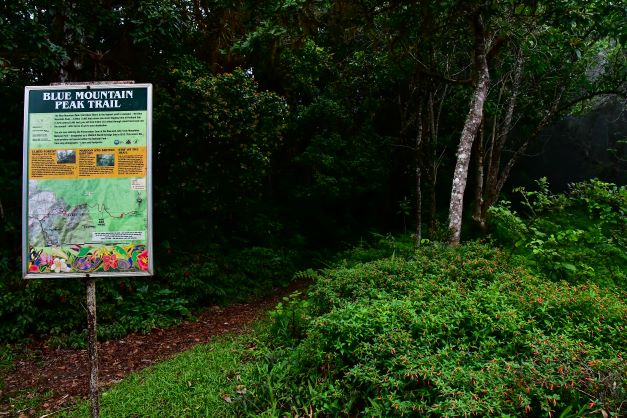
{"left": 243, "top": 243, "right": 627, "bottom": 416}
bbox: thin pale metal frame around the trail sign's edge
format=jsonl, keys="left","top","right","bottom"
{"left": 22, "top": 82, "right": 154, "bottom": 279}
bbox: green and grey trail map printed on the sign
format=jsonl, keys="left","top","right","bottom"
{"left": 28, "top": 178, "right": 148, "bottom": 247}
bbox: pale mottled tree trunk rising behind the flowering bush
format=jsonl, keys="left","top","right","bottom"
{"left": 449, "top": 12, "right": 490, "bottom": 245}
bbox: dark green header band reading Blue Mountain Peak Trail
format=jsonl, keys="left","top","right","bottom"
{"left": 28, "top": 87, "right": 148, "bottom": 113}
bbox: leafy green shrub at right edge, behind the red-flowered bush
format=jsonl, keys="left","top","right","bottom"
{"left": 490, "top": 179, "right": 627, "bottom": 291}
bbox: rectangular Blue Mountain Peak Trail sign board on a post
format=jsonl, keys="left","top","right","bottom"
{"left": 22, "top": 84, "right": 153, "bottom": 279}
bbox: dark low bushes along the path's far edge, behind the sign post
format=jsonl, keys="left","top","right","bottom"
{"left": 0, "top": 247, "right": 296, "bottom": 347}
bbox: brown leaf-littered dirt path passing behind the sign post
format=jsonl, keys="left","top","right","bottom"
{"left": 0, "top": 282, "right": 308, "bottom": 418}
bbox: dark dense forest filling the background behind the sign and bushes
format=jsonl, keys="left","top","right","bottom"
{"left": 0, "top": 0, "right": 627, "bottom": 340}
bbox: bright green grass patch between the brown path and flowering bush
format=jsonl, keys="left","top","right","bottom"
{"left": 62, "top": 337, "right": 249, "bottom": 418}
